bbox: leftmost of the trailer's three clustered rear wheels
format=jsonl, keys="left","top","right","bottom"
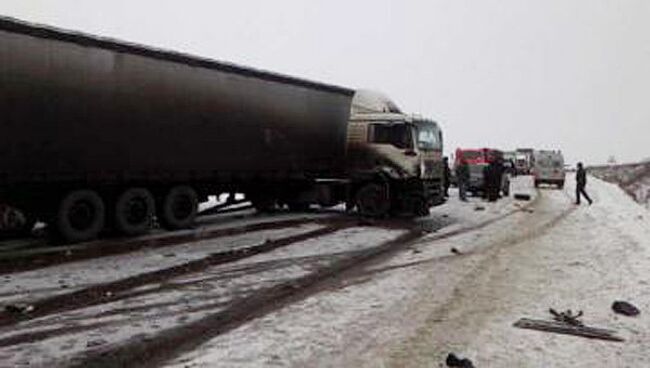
{"left": 55, "top": 190, "right": 106, "bottom": 243}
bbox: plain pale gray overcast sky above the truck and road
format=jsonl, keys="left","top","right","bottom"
{"left": 0, "top": 0, "right": 650, "bottom": 163}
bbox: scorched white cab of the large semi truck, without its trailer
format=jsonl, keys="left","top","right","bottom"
{"left": 348, "top": 91, "right": 444, "bottom": 215}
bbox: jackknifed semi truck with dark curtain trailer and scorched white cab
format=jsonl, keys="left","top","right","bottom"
{"left": 0, "top": 18, "right": 442, "bottom": 242}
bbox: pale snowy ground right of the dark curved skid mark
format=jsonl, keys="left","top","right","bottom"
{"left": 168, "top": 178, "right": 650, "bottom": 367}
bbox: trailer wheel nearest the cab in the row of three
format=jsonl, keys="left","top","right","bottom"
{"left": 158, "top": 186, "right": 199, "bottom": 230}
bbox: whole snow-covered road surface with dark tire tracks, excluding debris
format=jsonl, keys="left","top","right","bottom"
{"left": 0, "top": 178, "right": 650, "bottom": 368}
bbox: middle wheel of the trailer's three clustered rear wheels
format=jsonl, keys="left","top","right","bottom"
{"left": 114, "top": 188, "right": 155, "bottom": 236}
